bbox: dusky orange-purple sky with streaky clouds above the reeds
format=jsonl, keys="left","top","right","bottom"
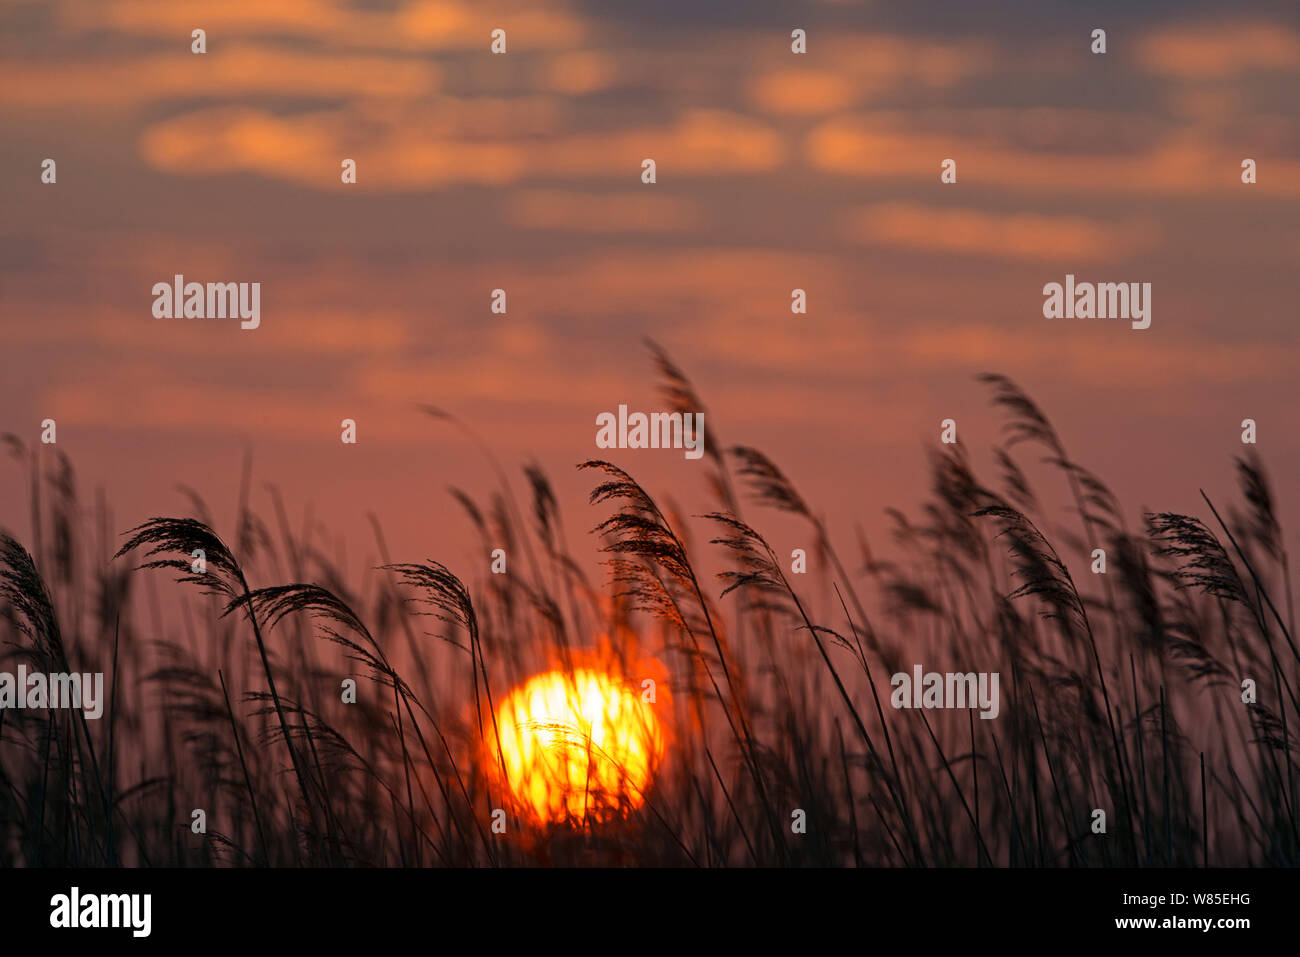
{"left": 0, "top": 0, "right": 1300, "bottom": 582}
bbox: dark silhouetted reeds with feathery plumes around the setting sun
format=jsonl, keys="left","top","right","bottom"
{"left": 0, "top": 358, "right": 1300, "bottom": 866}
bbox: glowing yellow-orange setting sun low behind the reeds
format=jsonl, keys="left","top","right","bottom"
{"left": 493, "top": 668, "right": 664, "bottom": 823}
